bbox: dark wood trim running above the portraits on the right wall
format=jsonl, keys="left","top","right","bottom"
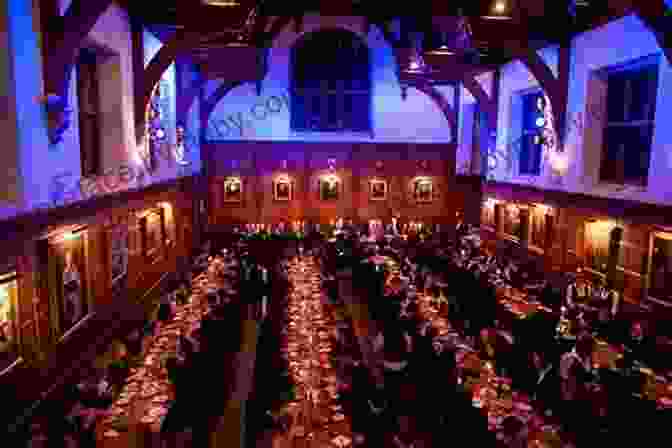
{"left": 485, "top": 182, "right": 672, "bottom": 226}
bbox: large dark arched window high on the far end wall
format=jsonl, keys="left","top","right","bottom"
{"left": 291, "top": 30, "right": 371, "bottom": 132}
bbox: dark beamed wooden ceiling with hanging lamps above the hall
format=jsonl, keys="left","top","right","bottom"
{"left": 125, "top": 0, "right": 630, "bottom": 82}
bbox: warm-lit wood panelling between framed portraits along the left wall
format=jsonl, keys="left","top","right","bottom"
{"left": 0, "top": 182, "right": 194, "bottom": 387}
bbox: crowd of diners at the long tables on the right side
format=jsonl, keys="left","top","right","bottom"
{"left": 316, "top": 224, "right": 672, "bottom": 446}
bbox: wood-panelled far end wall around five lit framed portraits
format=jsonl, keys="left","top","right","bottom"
{"left": 206, "top": 142, "right": 456, "bottom": 226}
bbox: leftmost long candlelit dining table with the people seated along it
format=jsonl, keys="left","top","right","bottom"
{"left": 25, "top": 247, "right": 252, "bottom": 448}
